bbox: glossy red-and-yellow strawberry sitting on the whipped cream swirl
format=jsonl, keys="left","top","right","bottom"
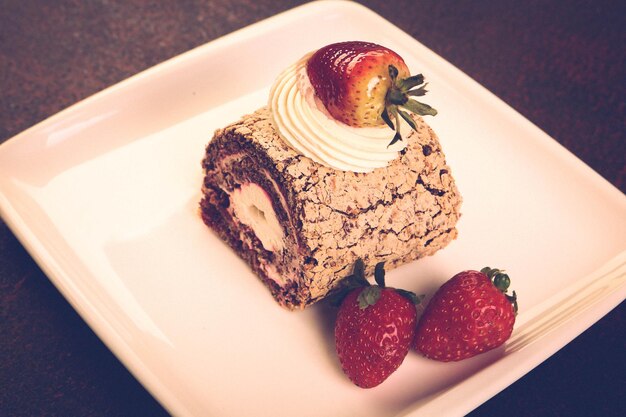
{"left": 307, "top": 41, "right": 437, "bottom": 142}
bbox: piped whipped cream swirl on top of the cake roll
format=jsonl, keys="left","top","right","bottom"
{"left": 269, "top": 54, "right": 411, "bottom": 172}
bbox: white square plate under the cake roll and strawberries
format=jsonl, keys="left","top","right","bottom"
{"left": 0, "top": 1, "right": 626, "bottom": 417}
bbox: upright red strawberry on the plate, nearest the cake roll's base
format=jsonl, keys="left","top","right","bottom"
{"left": 335, "top": 263, "right": 417, "bottom": 388}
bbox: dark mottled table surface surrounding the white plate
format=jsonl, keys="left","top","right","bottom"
{"left": 0, "top": 0, "right": 626, "bottom": 416}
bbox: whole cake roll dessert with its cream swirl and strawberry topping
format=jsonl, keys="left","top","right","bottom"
{"left": 200, "top": 41, "right": 461, "bottom": 309}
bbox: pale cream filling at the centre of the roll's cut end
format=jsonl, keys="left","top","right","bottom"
{"left": 230, "top": 183, "right": 285, "bottom": 252}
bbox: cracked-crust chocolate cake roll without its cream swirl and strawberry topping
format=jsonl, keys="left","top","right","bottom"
{"left": 200, "top": 108, "right": 461, "bottom": 309}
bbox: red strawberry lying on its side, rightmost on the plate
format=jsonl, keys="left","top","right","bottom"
{"left": 415, "top": 268, "right": 517, "bottom": 362}
